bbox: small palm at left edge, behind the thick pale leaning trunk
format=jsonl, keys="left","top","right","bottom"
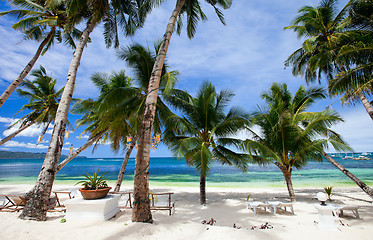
{"left": 0, "top": 66, "right": 63, "bottom": 145}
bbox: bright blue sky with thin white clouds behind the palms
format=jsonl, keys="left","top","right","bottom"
{"left": 0, "top": 0, "right": 373, "bottom": 157}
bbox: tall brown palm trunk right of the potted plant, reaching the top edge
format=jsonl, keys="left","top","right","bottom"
{"left": 132, "top": 0, "right": 185, "bottom": 223}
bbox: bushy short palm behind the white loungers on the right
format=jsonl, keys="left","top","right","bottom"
{"left": 243, "top": 83, "right": 349, "bottom": 201}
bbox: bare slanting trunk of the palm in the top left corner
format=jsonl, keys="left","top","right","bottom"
{"left": 0, "top": 27, "right": 55, "bottom": 107}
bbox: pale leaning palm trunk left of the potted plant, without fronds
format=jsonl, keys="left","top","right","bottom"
{"left": 19, "top": 20, "right": 95, "bottom": 221}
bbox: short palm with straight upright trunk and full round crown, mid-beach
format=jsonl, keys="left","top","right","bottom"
{"left": 164, "top": 82, "right": 248, "bottom": 204}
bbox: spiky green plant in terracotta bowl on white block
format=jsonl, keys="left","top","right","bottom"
{"left": 75, "top": 169, "right": 111, "bottom": 200}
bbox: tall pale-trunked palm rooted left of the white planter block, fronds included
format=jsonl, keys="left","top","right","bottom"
{"left": 20, "top": 0, "right": 143, "bottom": 221}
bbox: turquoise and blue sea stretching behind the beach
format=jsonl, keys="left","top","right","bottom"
{"left": 0, "top": 155, "right": 373, "bottom": 187}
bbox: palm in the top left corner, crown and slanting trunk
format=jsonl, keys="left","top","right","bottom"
{"left": 0, "top": 0, "right": 81, "bottom": 107}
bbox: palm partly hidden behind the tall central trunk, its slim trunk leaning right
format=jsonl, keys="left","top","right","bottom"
{"left": 114, "top": 43, "right": 179, "bottom": 191}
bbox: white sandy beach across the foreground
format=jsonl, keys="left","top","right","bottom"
{"left": 0, "top": 185, "right": 373, "bottom": 240}
